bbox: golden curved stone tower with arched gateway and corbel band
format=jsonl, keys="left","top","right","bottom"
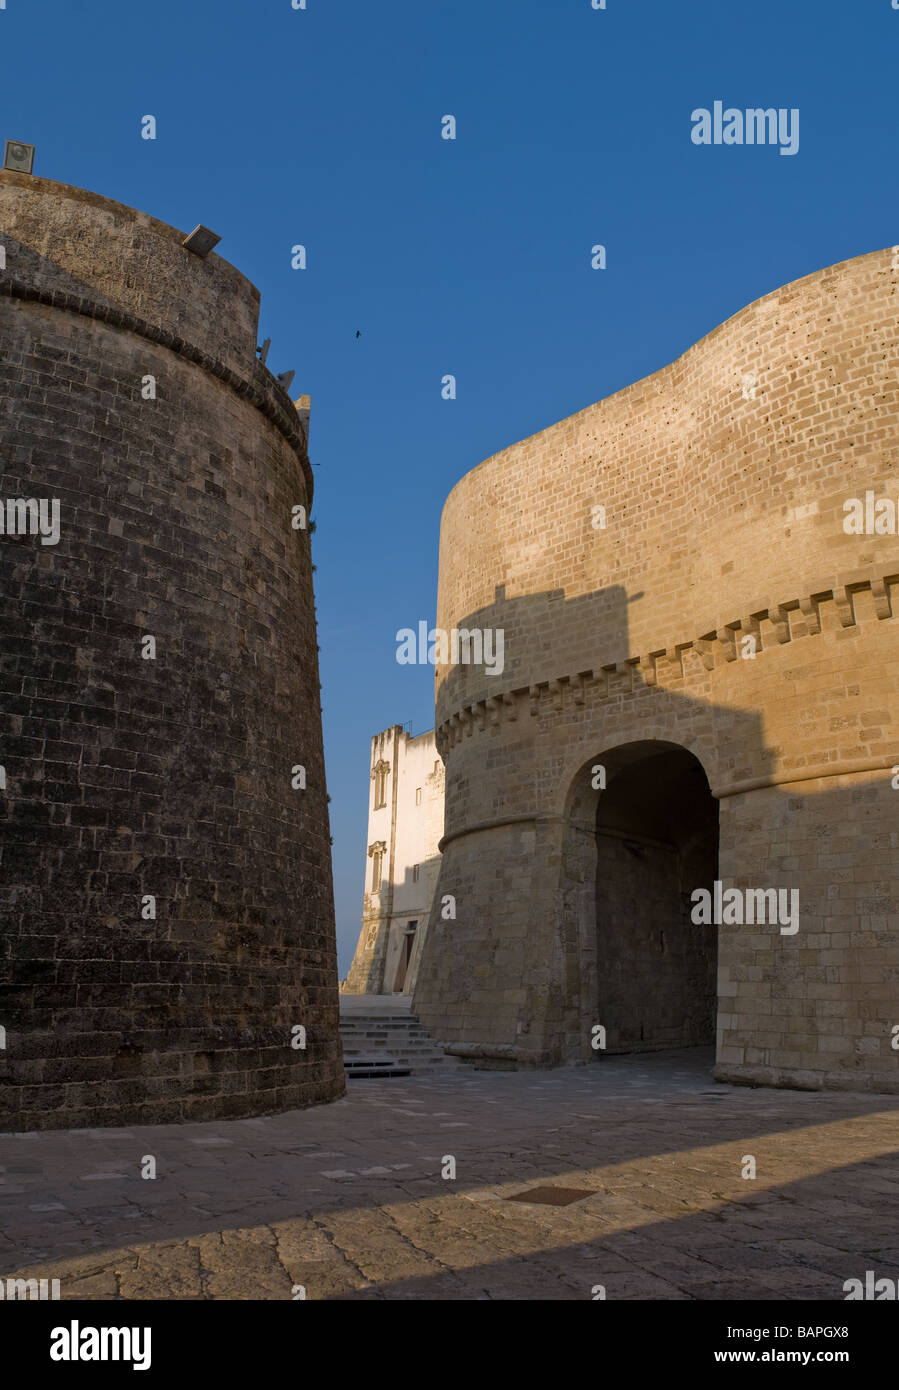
{"left": 414, "top": 250, "right": 899, "bottom": 1091}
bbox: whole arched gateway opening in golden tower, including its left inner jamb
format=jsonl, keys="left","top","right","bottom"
{"left": 560, "top": 739, "right": 718, "bottom": 1056}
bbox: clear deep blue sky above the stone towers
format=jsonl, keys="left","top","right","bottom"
{"left": 7, "top": 0, "right": 899, "bottom": 974}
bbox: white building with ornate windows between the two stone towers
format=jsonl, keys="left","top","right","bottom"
{"left": 340, "top": 724, "right": 443, "bottom": 994}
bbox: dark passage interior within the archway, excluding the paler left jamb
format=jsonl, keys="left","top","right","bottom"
{"left": 596, "top": 744, "right": 718, "bottom": 1052}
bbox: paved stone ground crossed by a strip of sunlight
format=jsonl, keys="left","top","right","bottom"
{"left": 0, "top": 1049, "right": 899, "bottom": 1300}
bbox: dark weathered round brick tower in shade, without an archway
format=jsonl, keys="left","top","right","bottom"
{"left": 0, "top": 172, "right": 345, "bottom": 1129}
